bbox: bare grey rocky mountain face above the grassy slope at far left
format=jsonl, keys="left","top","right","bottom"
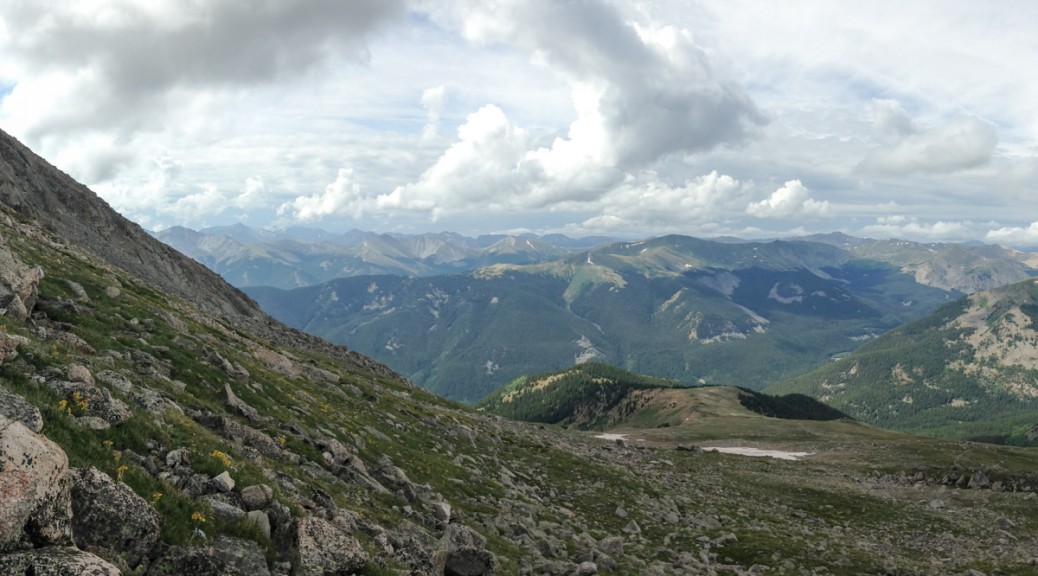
{"left": 0, "top": 131, "right": 262, "bottom": 316}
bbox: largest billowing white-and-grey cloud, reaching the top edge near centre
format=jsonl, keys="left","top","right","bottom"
{"left": 377, "top": 0, "right": 764, "bottom": 218}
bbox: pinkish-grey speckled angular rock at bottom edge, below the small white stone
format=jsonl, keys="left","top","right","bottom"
{"left": 293, "top": 516, "right": 367, "bottom": 576}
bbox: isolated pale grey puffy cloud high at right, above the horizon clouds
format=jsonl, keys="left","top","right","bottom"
{"left": 857, "top": 101, "right": 999, "bottom": 175}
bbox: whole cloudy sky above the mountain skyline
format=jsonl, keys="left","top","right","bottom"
{"left": 0, "top": 0, "right": 1038, "bottom": 247}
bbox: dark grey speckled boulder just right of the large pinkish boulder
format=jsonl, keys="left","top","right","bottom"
{"left": 72, "top": 468, "right": 161, "bottom": 568}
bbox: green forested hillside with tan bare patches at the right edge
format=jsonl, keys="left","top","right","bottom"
{"left": 770, "top": 280, "right": 1038, "bottom": 443}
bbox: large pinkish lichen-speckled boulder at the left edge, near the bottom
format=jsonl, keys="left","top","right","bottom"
{"left": 0, "top": 416, "right": 72, "bottom": 552}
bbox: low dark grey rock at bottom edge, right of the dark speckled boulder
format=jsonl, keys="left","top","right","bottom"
{"left": 146, "top": 537, "right": 270, "bottom": 576}
